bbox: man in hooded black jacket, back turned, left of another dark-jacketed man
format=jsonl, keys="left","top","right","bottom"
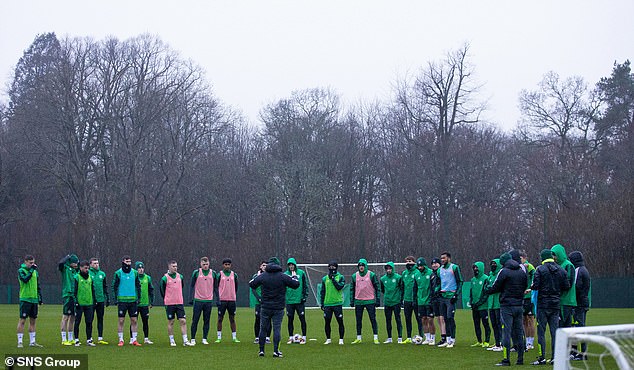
{"left": 486, "top": 253, "right": 528, "bottom": 366}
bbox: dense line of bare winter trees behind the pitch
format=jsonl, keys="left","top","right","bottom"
{"left": 0, "top": 33, "right": 634, "bottom": 283}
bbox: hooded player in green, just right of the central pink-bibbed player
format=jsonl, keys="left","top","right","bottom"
{"left": 380, "top": 261, "right": 403, "bottom": 343}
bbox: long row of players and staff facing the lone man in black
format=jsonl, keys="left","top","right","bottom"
{"left": 18, "top": 244, "right": 589, "bottom": 366}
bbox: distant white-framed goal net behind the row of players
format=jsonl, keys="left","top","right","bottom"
{"left": 297, "top": 262, "right": 405, "bottom": 308}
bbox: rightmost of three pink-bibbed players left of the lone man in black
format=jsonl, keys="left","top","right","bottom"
{"left": 215, "top": 258, "right": 240, "bottom": 343}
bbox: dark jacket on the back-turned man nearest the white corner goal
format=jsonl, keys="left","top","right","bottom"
{"left": 531, "top": 258, "right": 570, "bottom": 310}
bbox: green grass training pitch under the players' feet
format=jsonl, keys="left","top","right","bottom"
{"left": 0, "top": 305, "right": 634, "bottom": 370}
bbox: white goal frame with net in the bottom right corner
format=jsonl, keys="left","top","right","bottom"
{"left": 555, "top": 324, "right": 634, "bottom": 370}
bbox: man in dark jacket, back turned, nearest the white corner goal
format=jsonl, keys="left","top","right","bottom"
{"left": 531, "top": 249, "right": 570, "bottom": 365}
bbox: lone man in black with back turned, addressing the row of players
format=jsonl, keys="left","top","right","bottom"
{"left": 249, "top": 257, "right": 299, "bottom": 357}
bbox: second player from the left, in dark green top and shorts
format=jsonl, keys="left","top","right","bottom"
{"left": 57, "top": 254, "right": 79, "bottom": 346}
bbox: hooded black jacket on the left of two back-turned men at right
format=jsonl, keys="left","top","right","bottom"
{"left": 486, "top": 253, "right": 528, "bottom": 306}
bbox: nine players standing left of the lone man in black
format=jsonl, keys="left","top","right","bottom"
{"left": 17, "top": 254, "right": 240, "bottom": 348}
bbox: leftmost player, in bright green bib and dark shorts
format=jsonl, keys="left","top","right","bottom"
{"left": 17, "top": 254, "right": 43, "bottom": 348}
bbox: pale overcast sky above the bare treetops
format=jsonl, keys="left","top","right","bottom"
{"left": 0, "top": 0, "right": 634, "bottom": 130}
